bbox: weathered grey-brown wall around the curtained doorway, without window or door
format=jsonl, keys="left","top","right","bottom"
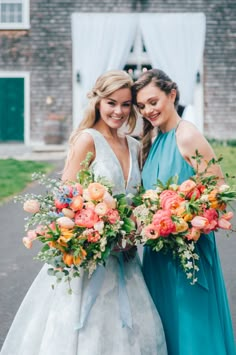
{"left": 0, "top": 0, "right": 236, "bottom": 142}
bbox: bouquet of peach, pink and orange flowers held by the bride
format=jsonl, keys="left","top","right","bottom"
{"left": 16, "top": 154, "right": 135, "bottom": 292}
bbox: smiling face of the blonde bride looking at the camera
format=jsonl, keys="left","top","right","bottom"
{"left": 98, "top": 88, "right": 132, "bottom": 129}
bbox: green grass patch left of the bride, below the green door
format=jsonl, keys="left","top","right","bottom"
{"left": 0, "top": 159, "right": 53, "bottom": 202}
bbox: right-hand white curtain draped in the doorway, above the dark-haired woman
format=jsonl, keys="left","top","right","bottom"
{"left": 140, "top": 13, "right": 206, "bottom": 105}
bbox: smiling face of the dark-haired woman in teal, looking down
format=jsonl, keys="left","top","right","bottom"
{"left": 136, "top": 83, "right": 176, "bottom": 128}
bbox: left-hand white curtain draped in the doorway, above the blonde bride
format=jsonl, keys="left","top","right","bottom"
{"left": 72, "top": 13, "right": 138, "bottom": 106}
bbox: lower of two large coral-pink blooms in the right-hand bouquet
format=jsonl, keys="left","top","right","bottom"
{"left": 152, "top": 210, "right": 176, "bottom": 237}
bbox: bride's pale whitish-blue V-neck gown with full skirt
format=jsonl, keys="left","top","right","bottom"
{"left": 1, "top": 129, "right": 167, "bottom": 355}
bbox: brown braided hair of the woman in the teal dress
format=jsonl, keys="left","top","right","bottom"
{"left": 132, "top": 69, "right": 179, "bottom": 166}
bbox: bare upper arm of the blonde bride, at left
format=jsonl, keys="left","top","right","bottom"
{"left": 62, "top": 132, "right": 95, "bottom": 181}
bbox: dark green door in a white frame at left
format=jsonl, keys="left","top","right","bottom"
{"left": 0, "top": 78, "right": 24, "bottom": 142}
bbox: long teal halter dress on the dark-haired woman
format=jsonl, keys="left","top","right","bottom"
{"left": 142, "top": 129, "right": 236, "bottom": 355}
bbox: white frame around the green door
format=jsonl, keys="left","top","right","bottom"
{"left": 0, "top": 71, "right": 30, "bottom": 146}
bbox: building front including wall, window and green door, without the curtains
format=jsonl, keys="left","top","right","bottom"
{"left": 0, "top": 0, "right": 236, "bottom": 146}
